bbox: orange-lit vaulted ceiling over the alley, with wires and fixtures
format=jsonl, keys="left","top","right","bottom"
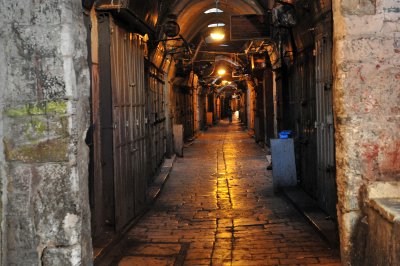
{"left": 96, "top": 0, "right": 304, "bottom": 86}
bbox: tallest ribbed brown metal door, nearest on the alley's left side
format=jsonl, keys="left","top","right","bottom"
{"left": 110, "top": 19, "right": 147, "bottom": 231}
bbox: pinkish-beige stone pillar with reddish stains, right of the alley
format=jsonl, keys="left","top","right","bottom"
{"left": 333, "top": 0, "right": 400, "bottom": 265}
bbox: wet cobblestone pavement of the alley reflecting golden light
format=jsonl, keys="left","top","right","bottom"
{"left": 103, "top": 119, "right": 340, "bottom": 266}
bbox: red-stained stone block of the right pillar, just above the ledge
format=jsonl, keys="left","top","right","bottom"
{"left": 336, "top": 119, "right": 400, "bottom": 182}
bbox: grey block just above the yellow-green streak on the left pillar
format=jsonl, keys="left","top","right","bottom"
{"left": 5, "top": 24, "right": 65, "bottom": 101}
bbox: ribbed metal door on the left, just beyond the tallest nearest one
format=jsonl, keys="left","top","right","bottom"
{"left": 146, "top": 62, "right": 166, "bottom": 176}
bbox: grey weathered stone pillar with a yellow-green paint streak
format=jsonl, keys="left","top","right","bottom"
{"left": 0, "top": 0, "right": 92, "bottom": 265}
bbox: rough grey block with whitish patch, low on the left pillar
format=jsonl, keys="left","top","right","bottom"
{"left": 31, "top": 165, "right": 81, "bottom": 246}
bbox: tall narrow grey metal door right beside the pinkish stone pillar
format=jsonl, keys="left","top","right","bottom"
{"left": 315, "top": 21, "right": 337, "bottom": 217}
